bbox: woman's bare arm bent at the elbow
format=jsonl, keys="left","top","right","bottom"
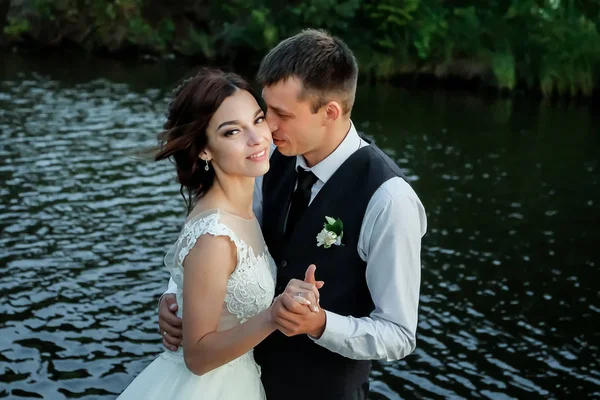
{"left": 183, "top": 235, "right": 275, "bottom": 375}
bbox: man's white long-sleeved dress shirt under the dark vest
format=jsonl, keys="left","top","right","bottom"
{"left": 166, "top": 124, "right": 427, "bottom": 361}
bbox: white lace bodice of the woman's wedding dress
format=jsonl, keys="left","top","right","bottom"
{"left": 165, "top": 210, "right": 276, "bottom": 330}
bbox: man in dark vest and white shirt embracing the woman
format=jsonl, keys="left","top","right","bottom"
{"left": 159, "top": 30, "right": 426, "bottom": 400}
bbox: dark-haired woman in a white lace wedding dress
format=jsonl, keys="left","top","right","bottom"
{"left": 119, "top": 69, "right": 310, "bottom": 400}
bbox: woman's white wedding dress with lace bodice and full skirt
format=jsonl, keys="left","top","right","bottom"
{"left": 119, "top": 210, "right": 276, "bottom": 400}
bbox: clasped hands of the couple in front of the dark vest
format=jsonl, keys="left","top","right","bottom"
{"left": 271, "top": 265, "right": 326, "bottom": 338}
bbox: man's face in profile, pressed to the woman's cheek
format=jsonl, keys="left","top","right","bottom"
{"left": 263, "top": 77, "right": 325, "bottom": 156}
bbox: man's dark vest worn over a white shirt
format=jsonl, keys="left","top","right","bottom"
{"left": 254, "top": 145, "right": 404, "bottom": 400}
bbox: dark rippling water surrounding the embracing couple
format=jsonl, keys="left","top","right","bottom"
{"left": 0, "top": 56, "right": 600, "bottom": 399}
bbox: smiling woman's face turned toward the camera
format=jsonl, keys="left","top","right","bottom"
{"left": 199, "top": 90, "right": 271, "bottom": 177}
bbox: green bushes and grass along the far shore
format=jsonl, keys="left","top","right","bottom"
{"left": 0, "top": 0, "right": 600, "bottom": 97}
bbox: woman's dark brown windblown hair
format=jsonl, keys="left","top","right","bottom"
{"left": 154, "top": 68, "right": 256, "bottom": 212}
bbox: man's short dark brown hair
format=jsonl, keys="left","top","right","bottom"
{"left": 257, "top": 29, "right": 358, "bottom": 114}
